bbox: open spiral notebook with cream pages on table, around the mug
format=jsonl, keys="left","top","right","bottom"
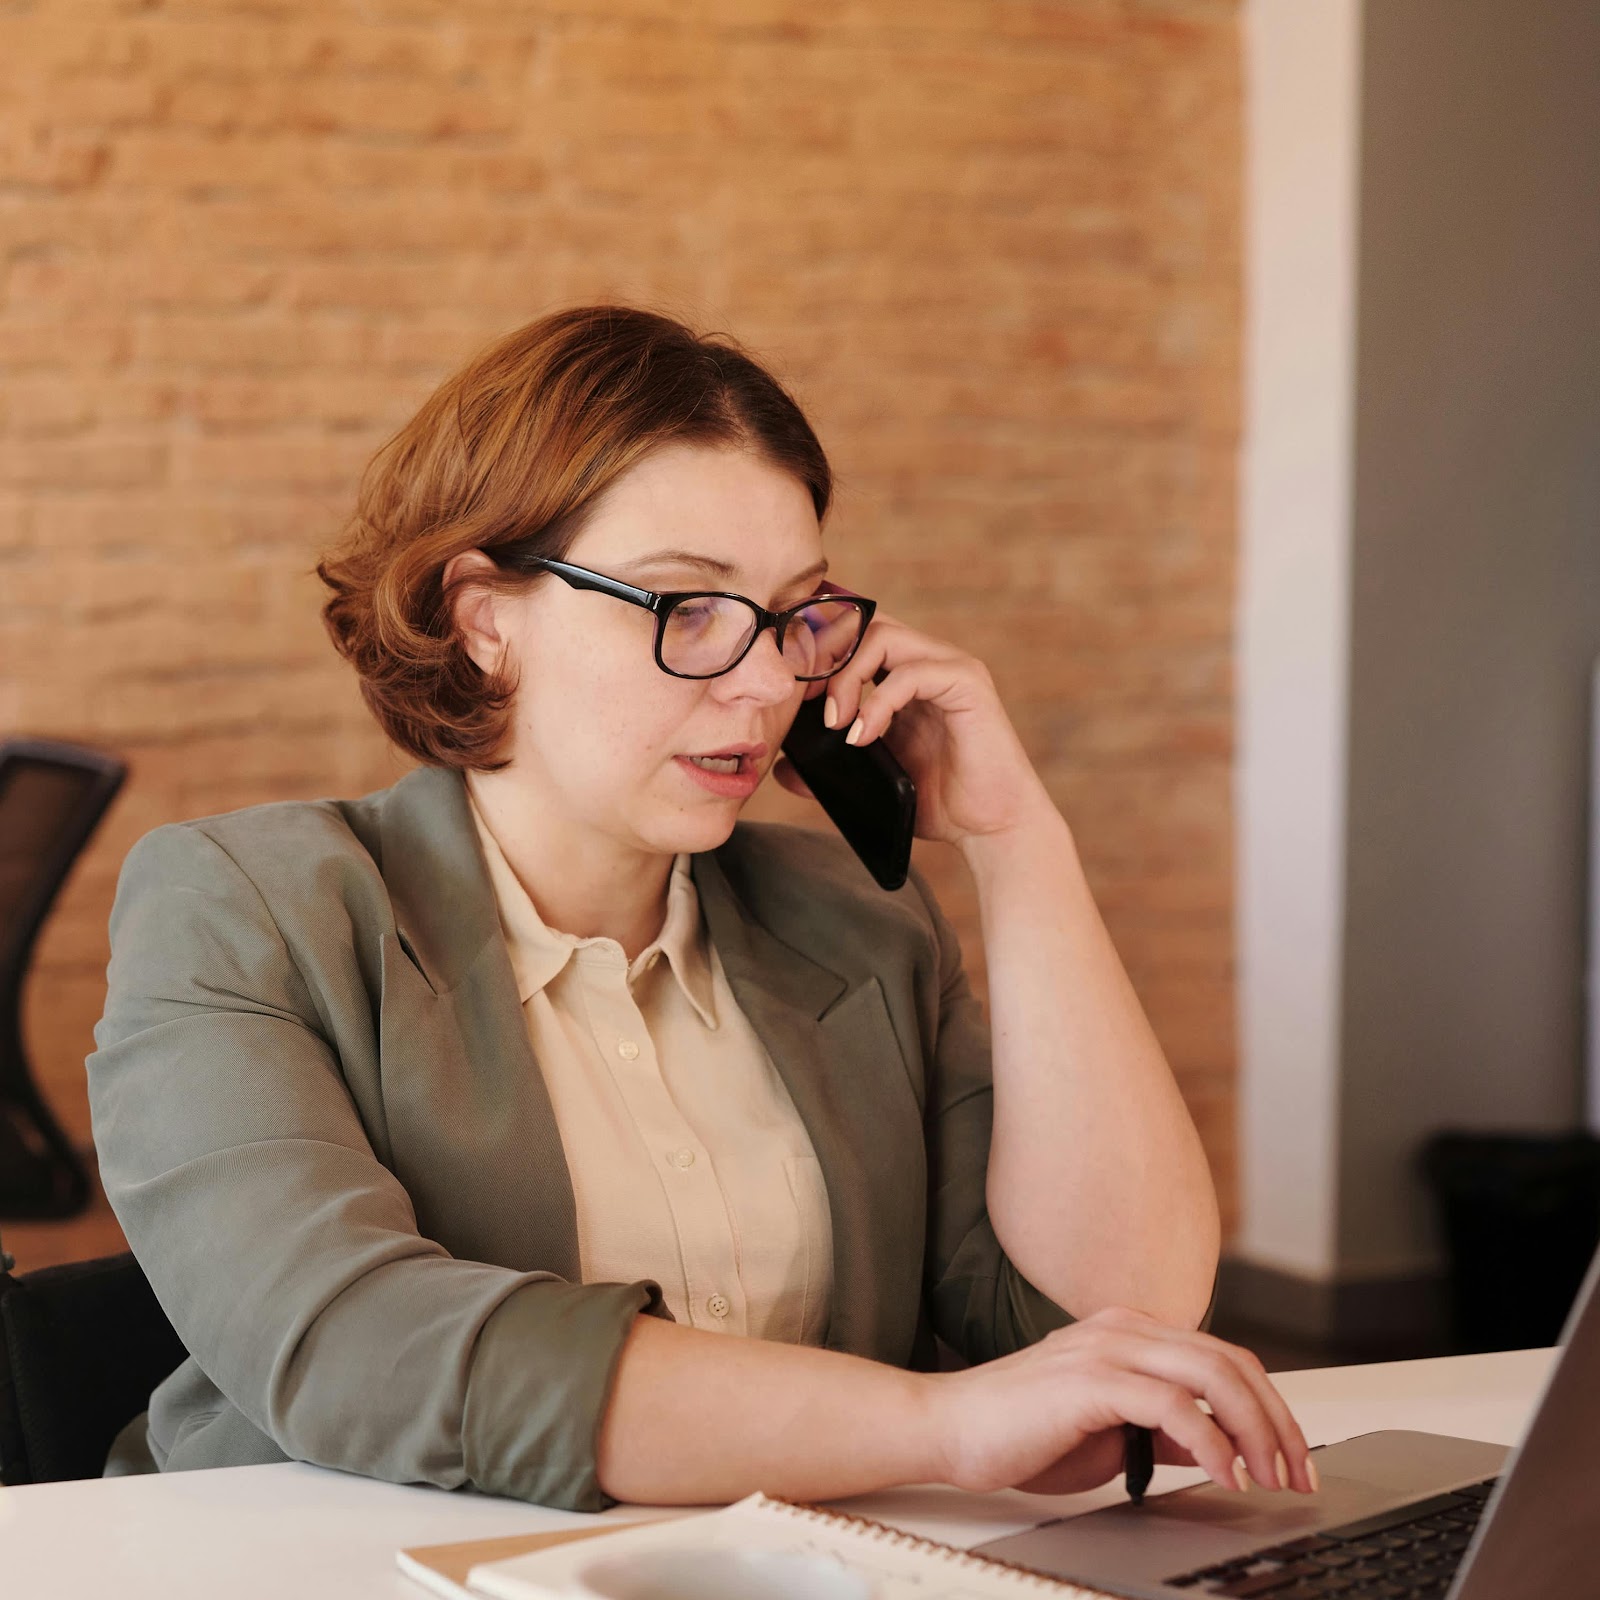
{"left": 400, "top": 1493, "right": 1114, "bottom": 1600}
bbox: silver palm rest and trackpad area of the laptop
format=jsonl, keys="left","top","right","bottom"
{"left": 974, "top": 1430, "right": 1509, "bottom": 1592}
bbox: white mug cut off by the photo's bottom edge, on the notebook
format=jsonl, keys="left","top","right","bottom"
{"left": 566, "top": 1547, "right": 877, "bottom": 1600}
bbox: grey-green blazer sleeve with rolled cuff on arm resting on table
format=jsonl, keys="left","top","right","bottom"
{"left": 88, "top": 824, "right": 662, "bottom": 1510}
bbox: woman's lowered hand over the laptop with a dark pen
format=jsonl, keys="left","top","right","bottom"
{"left": 926, "top": 1307, "right": 1317, "bottom": 1494}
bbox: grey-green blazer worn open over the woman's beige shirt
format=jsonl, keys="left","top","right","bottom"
{"left": 88, "top": 768, "right": 1070, "bottom": 1510}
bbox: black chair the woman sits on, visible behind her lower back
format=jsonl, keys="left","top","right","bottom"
{"left": 0, "top": 1254, "right": 186, "bottom": 1478}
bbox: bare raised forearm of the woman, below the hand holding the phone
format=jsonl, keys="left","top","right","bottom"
{"left": 963, "top": 805, "right": 1219, "bottom": 1326}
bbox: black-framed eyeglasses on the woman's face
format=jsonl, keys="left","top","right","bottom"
{"left": 488, "top": 549, "right": 877, "bottom": 683}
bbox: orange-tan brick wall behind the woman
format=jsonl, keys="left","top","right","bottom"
{"left": 0, "top": 0, "right": 1240, "bottom": 1228}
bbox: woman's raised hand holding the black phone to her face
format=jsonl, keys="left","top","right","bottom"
{"left": 774, "top": 611, "right": 1051, "bottom": 845}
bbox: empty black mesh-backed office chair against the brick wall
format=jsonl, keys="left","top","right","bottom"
{"left": 0, "top": 739, "right": 128, "bottom": 1219}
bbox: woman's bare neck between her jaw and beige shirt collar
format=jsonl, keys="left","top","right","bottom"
{"left": 467, "top": 773, "right": 674, "bottom": 960}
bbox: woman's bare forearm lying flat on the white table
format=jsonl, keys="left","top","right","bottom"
{"left": 598, "top": 1317, "right": 942, "bottom": 1506}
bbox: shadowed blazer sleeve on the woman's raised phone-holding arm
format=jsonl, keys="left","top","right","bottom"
{"left": 912, "top": 867, "right": 1074, "bottom": 1365}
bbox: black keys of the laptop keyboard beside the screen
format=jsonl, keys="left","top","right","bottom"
{"left": 1166, "top": 1478, "right": 1496, "bottom": 1600}
